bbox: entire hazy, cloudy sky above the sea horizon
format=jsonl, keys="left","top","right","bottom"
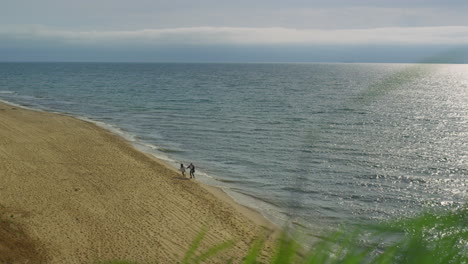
{"left": 0, "top": 0, "right": 468, "bottom": 63}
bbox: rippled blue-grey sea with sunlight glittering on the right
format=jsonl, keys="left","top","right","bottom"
{"left": 0, "top": 63, "right": 468, "bottom": 234}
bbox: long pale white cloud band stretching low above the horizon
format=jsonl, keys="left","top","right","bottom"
{"left": 0, "top": 25, "right": 468, "bottom": 46}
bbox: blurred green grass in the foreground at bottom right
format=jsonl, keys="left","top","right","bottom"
{"left": 100, "top": 206, "right": 468, "bottom": 264}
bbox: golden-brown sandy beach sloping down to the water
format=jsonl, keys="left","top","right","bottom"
{"left": 0, "top": 103, "right": 275, "bottom": 263}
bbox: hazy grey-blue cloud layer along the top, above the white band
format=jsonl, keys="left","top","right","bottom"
{"left": 0, "top": 0, "right": 468, "bottom": 30}
